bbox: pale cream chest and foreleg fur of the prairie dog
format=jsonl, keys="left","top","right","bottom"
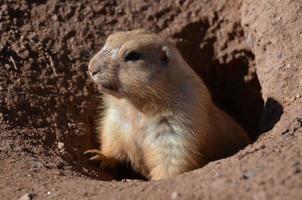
{"left": 101, "top": 96, "right": 198, "bottom": 178}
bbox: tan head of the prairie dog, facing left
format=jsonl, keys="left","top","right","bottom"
{"left": 88, "top": 30, "right": 201, "bottom": 111}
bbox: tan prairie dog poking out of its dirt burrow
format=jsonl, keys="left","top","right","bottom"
{"left": 87, "top": 30, "right": 250, "bottom": 180}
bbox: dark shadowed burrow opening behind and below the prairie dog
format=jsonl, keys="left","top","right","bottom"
{"left": 74, "top": 19, "right": 264, "bottom": 179}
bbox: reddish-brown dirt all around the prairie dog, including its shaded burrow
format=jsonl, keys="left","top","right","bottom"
{"left": 0, "top": 0, "right": 302, "bottom": 200}
